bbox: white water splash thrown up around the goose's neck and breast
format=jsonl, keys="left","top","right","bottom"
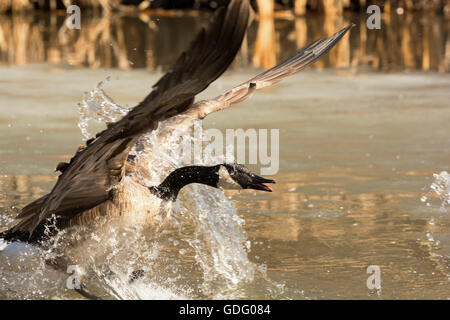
{"left": 64, "top": 83, "right": 258, "bottom": 299}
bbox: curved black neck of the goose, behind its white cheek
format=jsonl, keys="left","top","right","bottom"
{"left": 150, "top": 165, "right": 220, "bottom": 201}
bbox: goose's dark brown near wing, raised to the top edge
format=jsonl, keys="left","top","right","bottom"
{"left": 13, "top": 0, "right": 249, "bottom": 236}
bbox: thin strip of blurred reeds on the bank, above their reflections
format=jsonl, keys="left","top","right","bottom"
{"left": 0, "top": 0, "right": 450, "bottom": 16}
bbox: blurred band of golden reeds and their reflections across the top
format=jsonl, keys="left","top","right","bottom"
{"left": 0, "top": 0, "right": 450, "bottom": 72}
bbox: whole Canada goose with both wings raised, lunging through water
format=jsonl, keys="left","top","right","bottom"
{"left": 0, "top": 0, "right": 353, "bottom": 246}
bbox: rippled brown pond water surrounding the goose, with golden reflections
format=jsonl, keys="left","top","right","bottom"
{"left": 0, "top": 10, "right": 450, "bottom": 299}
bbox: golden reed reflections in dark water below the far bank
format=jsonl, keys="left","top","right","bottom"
{"left": 0, "top": 14, "right": 450, "bottom": 72}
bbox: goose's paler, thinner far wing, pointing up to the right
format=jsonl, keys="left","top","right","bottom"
{"left": 178, "top": 24, "right": 355, "bottom": 121}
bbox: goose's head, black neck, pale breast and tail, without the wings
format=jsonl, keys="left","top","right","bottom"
{"left": 0, "top": 163, "right": 275, "bottom": 242}
